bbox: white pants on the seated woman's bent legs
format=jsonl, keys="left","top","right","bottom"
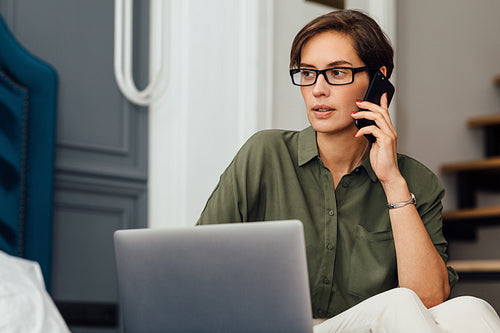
{"left": 314, "top": 288, "right": 500, "bottom": 333}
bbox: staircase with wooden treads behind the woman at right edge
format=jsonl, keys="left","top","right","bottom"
{"left": 441, "top": 96, "right": 500, "bottom": 279}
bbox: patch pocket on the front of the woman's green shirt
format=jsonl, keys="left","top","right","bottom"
{"left": 348, "top": 225, "right": 397, "bottom": 299}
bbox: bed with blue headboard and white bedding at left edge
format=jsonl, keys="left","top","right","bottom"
{"left": 0, "top": 12, "right": 68, "bottom": 332}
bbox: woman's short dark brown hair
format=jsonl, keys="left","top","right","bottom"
{"left": 290, "top": 10, "right": 394, "bottom": 77}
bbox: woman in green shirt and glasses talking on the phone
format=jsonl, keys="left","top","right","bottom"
{"left": 198, "top": 10, "right": 500, "bottom": 332}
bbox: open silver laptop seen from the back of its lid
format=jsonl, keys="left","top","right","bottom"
{"left": 114, "top": 220, "right": 312, "bottom": 332}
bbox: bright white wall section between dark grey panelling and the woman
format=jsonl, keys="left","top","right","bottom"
{"left": 148, "top": 0, "right": 273, "bottom": 227}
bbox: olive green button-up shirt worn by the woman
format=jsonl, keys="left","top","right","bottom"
{"left": 198, "top": 127, "right": 457, "bottom": 318}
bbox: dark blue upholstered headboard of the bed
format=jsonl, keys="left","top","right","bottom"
{"left": 0, "top": 16, "right": 57, "bottom": 288}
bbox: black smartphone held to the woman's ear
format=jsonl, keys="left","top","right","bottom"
{"left": 355, "top": 71, "right": 395, "bottom": 143}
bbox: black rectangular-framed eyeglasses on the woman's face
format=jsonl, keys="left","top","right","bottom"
{"left": 290, "top": 67, "right": 369, "bottom": 87}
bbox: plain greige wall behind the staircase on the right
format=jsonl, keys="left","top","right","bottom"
{"left": 397, "top": 0, "right": 500, "bottom": 311}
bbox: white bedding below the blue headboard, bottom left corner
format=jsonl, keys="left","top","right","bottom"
{"left": 0, "top": 251, "right": 69, "bottom": 333}
